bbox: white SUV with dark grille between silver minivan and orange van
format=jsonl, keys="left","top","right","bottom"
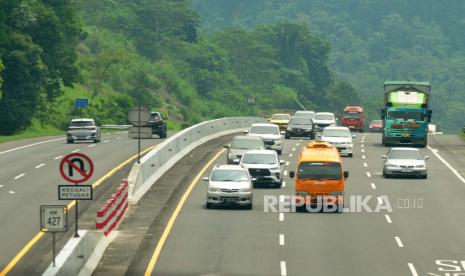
{"left": 240, "top": 150, "right": 285, "bottom": 188}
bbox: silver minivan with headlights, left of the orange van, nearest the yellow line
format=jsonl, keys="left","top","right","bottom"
{"left": 203, "top": 165, "right": 253, "bottom": 209}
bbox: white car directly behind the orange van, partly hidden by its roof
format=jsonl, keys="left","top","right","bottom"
{"left": 321, "top": 126, "right": 355, "bottom": 157}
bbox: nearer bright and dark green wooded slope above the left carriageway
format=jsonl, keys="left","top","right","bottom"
{"left": 0, "top": 0, "right": 360, "bottom": 135}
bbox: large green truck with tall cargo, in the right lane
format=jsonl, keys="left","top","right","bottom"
{"left": 381, "top": 81, "right": 432, "bottom": 147}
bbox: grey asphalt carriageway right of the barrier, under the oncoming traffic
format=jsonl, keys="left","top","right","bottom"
{"left": 99, "top": 133, "right": 465, "bottom": 276}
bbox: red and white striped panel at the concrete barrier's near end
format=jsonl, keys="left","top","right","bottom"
{"left": 96, "top": 180, "right": 129, "bottom": 236}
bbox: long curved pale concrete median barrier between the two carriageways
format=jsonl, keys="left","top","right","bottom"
{"left": 128, "top": 117, "right": 265, "bottom": 203}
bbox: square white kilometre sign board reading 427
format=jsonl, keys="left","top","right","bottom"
{"left": 40, "top": 205, "right": 68, "bottom": 232}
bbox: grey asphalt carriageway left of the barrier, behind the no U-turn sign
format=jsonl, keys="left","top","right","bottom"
{"left": 0, "top": 132, "right": 166, "bottom": 271}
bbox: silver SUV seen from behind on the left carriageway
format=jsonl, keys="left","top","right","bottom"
{"left": 66, "top": 118, "right": 101, "bottom": 144}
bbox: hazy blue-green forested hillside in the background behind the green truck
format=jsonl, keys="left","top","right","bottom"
{"left": 194, "top": 0, "right": 465, "bottom": 132}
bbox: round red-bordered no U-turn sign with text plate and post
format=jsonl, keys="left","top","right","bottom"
{"left": 58, "top": 153, "right": 94, "bottom": 237}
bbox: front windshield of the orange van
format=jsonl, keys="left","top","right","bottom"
{"left": 298, "top": 162, "right": 342, "bottom": 179}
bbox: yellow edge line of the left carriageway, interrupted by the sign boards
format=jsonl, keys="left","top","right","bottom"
{"left": 0, "top": 144, "right": 159, "bottom": 276}
